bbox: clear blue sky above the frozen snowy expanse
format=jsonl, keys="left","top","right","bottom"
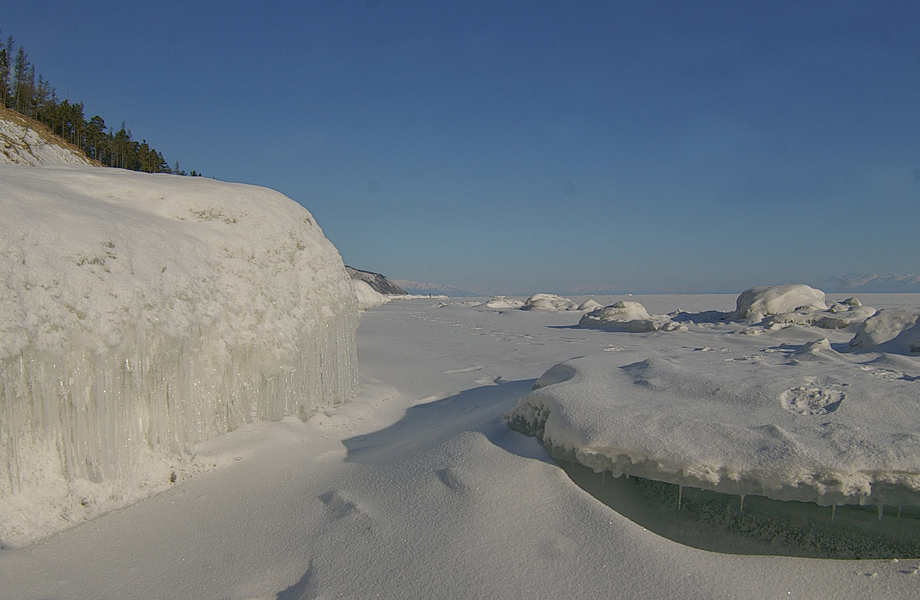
{"left": 0, "top": 0, "right": 920, "bottom": 293}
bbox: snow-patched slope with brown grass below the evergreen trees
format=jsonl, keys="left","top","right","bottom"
{"left": 0, "top": 108, "right": 92, "bottom": 167}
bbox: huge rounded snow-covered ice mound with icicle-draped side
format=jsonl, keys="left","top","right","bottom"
{"left": 0, "top": 166, "right": 358, "bottom": 542}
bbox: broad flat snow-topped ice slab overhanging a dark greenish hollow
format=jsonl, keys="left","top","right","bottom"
{"left": 505, "top": 340, "right": 920, "bottom": 506}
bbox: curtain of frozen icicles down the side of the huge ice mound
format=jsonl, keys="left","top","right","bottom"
{"left": 0, "top": 307, "right": 358, "bottom": 496}
